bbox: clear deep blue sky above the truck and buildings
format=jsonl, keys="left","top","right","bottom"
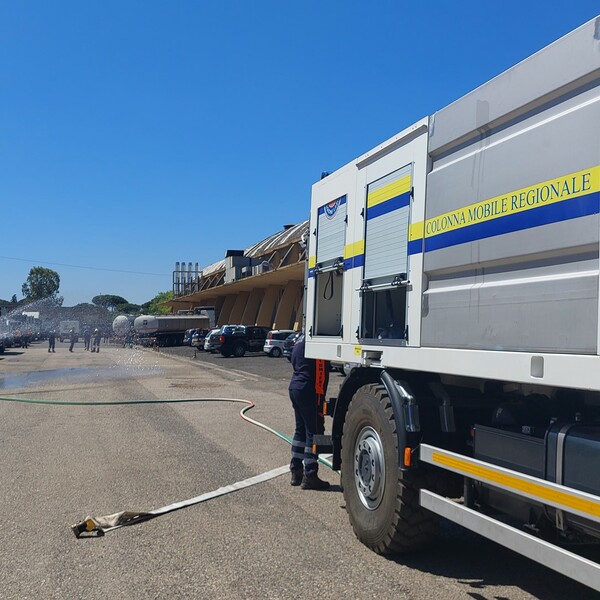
{"left": 0, "top": 0, "right": 600, "bottom": 305}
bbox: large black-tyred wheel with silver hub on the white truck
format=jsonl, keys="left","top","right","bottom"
{"left": 342, "top": 384, "right": 435, "bottom": 554}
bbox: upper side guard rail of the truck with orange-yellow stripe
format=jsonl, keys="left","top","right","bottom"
{"left": 420, "top": 444, "right": 600, "bottom": 522}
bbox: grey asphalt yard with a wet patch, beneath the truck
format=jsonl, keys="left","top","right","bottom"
{"left": 0, "top": 344, "right": 596, "bottom": 600}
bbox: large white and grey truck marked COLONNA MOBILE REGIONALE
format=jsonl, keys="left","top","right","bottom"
{"left": 306, "top": 17, "right": 600, "bottom": 590}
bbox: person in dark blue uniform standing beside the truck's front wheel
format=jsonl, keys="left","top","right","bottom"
{"left": 288, "top": 337, "right": 329, "bottom": 490}
